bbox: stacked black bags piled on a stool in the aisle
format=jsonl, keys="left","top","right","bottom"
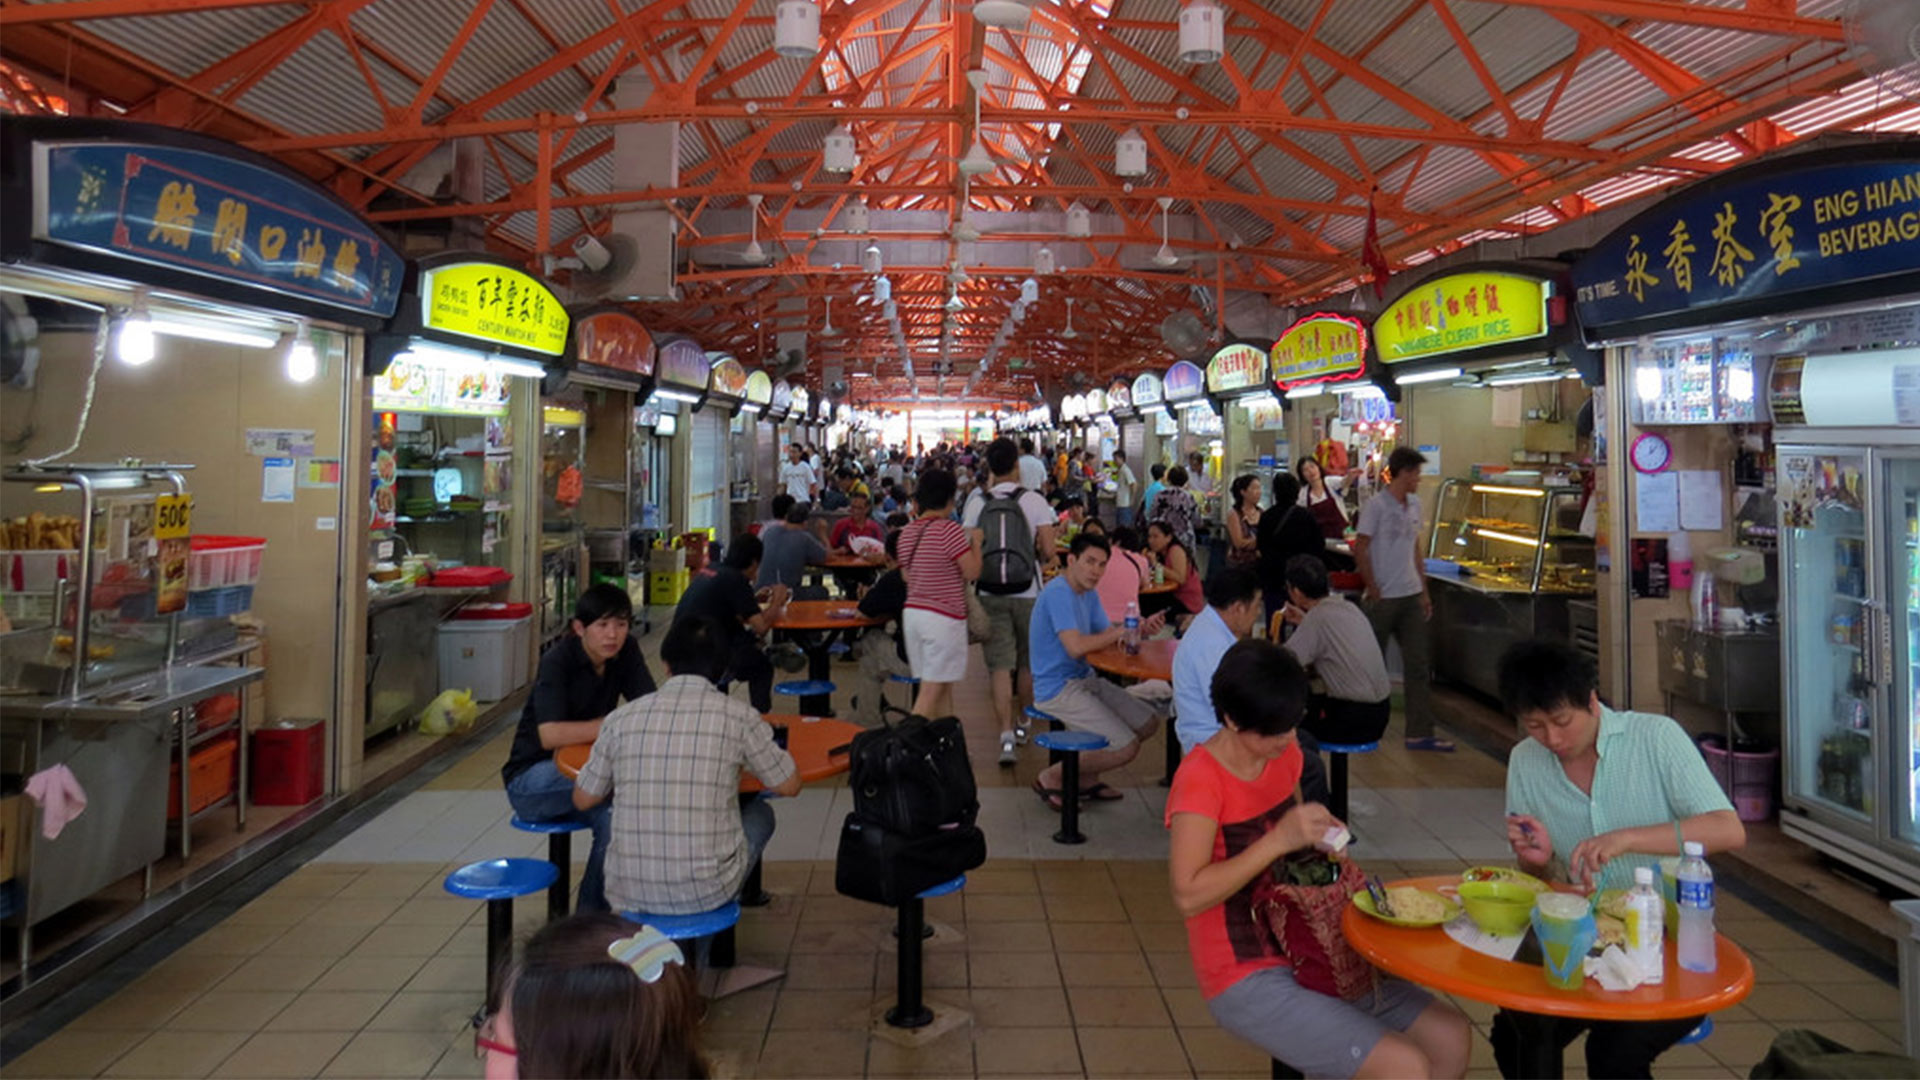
{"left": 833, "top": 709, "right": 987, "bottom": 907}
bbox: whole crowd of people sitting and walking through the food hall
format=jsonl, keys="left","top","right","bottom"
{"left": 478, "top": 436, "right": 1743, "bottom": 1076}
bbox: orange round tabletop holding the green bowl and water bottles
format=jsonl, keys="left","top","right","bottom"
{"left": 1340, "top": 876, "right": 1753, "bottom": 1020}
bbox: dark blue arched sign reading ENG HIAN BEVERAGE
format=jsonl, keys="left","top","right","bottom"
{"left": 1572, "top": 146, "right": 1920, "bottom": 336}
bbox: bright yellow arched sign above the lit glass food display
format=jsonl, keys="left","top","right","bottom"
{"left": 1373, "top": 271, "right": 1551, "bottom": 363}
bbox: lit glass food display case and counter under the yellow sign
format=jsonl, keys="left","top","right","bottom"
{"left": 1427, "top": 479, "right": 1594, "bottom": 694}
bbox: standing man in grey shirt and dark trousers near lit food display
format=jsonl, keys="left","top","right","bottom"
{"left": 1354, "top": 446, "right": 1453, "bottom": 753}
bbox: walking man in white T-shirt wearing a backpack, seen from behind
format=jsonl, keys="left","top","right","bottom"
{"left": 960, "top": 436, "right": 1054, "bottom": 765}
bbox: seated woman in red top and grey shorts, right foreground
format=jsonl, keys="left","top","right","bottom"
{"left": 1167, "top": 640, "right": 1473, "bottom": 1078}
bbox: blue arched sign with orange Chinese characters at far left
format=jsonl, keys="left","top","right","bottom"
{"left": 35, "top": 142, "right": 405, "bottom": 319}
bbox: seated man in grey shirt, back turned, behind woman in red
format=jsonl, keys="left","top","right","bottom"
{"left": 1284, "top": 555, "right": 1394, "bottom": 744}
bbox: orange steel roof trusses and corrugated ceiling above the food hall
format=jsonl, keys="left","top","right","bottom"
{"left": 0, "top": 0, "right": 1910, "bottom": 398}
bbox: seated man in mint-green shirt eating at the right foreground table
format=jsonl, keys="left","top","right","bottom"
{"left": 1492, "top": 642, "right": 1747, "bottom": 1078}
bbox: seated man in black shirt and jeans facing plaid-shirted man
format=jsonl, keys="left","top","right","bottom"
{"left": 499, "top": 584, "right": 653, "bottom": 911}
